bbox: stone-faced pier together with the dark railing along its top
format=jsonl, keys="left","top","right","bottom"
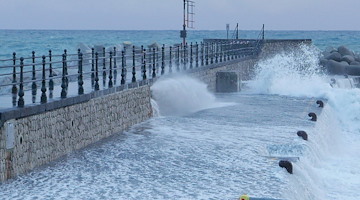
{"left": 0, "top": 40, "right": 310, "bottom": 181}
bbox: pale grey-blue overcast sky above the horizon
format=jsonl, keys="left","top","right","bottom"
{"left": 0, "top": 0, "right": 360, "bottom": 30}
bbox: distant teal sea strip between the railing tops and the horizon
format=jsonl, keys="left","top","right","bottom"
{"left": 0, "top": 30, "right": 360, "bottom": 59}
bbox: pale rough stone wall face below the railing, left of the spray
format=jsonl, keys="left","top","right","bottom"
{"left": 0, "top": 85, "right": 152, "bottom": 181}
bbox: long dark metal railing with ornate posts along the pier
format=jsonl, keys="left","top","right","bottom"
{"left": 0, "top": 39, "right": 260, "bottom": 107}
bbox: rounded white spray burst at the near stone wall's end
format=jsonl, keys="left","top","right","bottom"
{"left": 151, "top": 75, "right": 219, "bottom": 116}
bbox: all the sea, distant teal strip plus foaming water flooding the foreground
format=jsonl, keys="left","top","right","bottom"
{"left": 0, "top": 30, "right": 360, "bottom": 200}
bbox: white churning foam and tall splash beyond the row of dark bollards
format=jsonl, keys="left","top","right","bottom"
{"left": 248, "top": 46, "right": 360, "bottom": 199}
